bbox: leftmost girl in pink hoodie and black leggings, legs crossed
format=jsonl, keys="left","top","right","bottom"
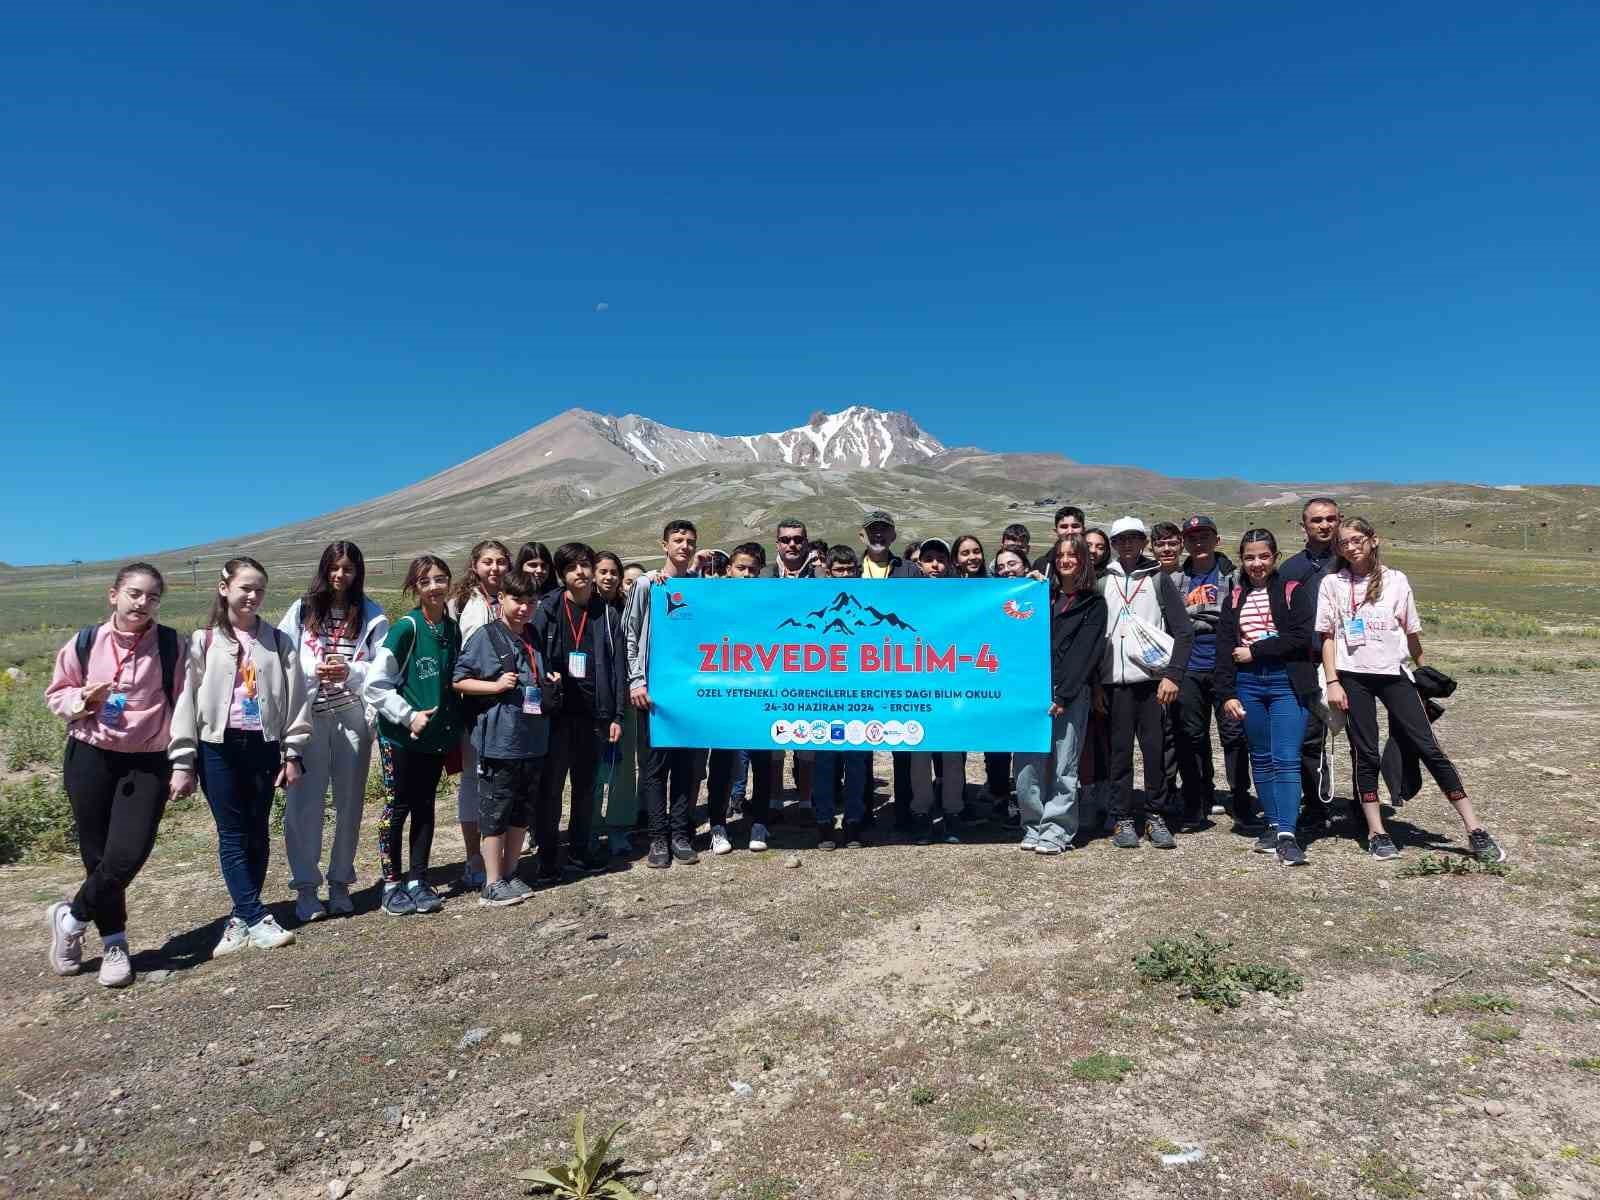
{"left": 45, "top": 563, "right": 182, "bottom": 987}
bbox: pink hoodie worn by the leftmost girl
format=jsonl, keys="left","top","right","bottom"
{"left": 45, "top": 621, "right": 181, "bottom": 754}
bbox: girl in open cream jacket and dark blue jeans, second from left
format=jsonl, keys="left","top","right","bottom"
{"left": 168, "top": 555, "right": 310, "bottom": 958}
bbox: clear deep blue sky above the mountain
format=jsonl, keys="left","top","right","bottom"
{"left": 0, "top": 3, "right": 1600, "bottom": 562}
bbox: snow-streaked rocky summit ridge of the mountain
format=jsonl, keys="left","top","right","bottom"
{"left": 598, "top": 405, "right": 944, "bottom": 474}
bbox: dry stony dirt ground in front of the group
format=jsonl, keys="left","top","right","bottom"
{"left": 0, "top": 643, "right": 1600, "bottom": 1200}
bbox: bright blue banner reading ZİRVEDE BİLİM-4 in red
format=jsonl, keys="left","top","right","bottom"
{"left": 650, "top": 579, "right": 1050, "bottom": 752}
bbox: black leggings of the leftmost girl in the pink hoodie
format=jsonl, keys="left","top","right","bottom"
{"left": 61, "top": 738, "right": 173, "bottom": 938}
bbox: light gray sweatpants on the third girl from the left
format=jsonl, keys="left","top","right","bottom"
{"left": 283, "top": 704, "right": 373, "bottom": 891}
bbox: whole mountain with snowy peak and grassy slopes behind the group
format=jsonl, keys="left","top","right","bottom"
{"left": 12, "top": 406, "right": 1600, "bottom": 584}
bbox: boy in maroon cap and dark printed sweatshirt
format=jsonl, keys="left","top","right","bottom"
{"left": 1173, "top": 514, "right": 1256, "bottom": 826}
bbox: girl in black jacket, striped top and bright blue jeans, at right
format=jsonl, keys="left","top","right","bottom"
{"left": 1213, "top": 530, "right": 1318, "bottom": 867}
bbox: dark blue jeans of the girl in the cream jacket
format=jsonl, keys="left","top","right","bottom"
{"left": 200, "top": 730, "right": 282, "bottom": 925}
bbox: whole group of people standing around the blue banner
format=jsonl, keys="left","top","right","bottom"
{"left": 46, "top": 498, "right": 1506, "bottom": 987}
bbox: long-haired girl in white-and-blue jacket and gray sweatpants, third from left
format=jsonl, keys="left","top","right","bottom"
{"left": 278, "top": 541, "right": 389, "bottom": 922}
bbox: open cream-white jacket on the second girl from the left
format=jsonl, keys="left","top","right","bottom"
{"left": 166, "top": 621, "right": 310, "bottom": 770}
